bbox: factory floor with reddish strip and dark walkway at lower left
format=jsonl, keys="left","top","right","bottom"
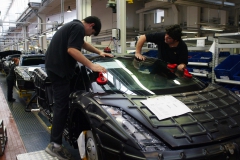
{"left": 0, "top": 73, "right": 80, "bottom": 160}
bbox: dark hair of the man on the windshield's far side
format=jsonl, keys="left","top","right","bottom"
{"left": 165, "top": 24, "right": 182, "bottom": 41}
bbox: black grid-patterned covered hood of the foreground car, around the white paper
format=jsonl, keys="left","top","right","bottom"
{"left": 95, "top": 84, "right": 240, "bottom": 148}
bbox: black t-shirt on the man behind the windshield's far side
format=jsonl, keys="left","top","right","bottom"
{"left": 146, "top": 33, "right": 188, "bottom": 65}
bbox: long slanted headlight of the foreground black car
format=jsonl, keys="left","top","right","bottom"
{"left": 102, "top": 105, "right": 168, "bottom": 152}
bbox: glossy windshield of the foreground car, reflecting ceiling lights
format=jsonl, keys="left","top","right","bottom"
{"left": 91, "top": 57, "right": 206, "bottom": 95}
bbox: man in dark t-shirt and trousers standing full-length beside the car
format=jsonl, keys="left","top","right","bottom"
{"left": 45, "top": 16, "right": 113, "bottom": 160}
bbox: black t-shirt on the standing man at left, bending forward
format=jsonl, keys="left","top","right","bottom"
{"left": 45, "top": 20, "right": 85, "bottom": 78}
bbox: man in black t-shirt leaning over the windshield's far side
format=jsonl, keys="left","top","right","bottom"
{"left": 135, "top": 25, "right": 188, "bottom": 71}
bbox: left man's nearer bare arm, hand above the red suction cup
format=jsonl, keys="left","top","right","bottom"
{"left": 68, "top": 48, "right": 107, "bottom": 73}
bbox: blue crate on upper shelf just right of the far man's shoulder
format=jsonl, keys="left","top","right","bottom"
{"left": 188, "top": 52, "right": 212, "bottom": 62}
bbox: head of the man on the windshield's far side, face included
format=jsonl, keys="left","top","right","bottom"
{"left": 165, "top": 24, "right": 182, "bottom": 43}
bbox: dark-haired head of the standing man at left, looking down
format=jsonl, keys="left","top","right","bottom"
{"left": 83, "top": 16, "right": 102, "bottom": 36}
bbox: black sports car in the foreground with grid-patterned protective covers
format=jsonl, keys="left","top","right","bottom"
{"left": 31, "top": 55, "right": 240, "bottom": 160}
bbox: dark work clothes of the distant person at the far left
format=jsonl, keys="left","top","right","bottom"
{"left": 6, "top": 63, "right": 16, "bottom": 101}
